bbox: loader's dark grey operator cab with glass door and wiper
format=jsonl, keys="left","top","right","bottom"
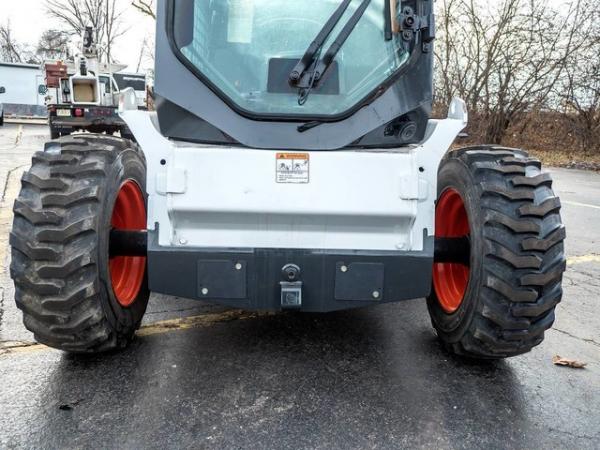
{"left": 155, "top": 0, "right": 434, "bottom": 150}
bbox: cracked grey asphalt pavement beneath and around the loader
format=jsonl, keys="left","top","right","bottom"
{"left": 0, "top": 124, "right": 600, "bottom": 449}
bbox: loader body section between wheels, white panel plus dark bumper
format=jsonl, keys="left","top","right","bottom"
{"left": 121, "top": 100, "right": 467, "bottom": 312}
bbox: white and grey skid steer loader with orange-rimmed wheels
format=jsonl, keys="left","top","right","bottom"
{"left": 10, "top": 0, "right": 565, "bottom": 359}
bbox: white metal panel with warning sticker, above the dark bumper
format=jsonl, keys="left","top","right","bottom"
{"left": 121, "top": 99, "right": 466, "bottom": 251}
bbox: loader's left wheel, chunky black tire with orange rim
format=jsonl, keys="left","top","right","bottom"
{"left": 10, "top": 135, "right": 149, "bottom": 353}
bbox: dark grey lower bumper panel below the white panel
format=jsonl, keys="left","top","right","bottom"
{"left": 148, "top": 234, "right": 433, "bottom": 312}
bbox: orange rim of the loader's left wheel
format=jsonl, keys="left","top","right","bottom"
{"left": 109, "top": 180, "right": 146, "bottom": 307}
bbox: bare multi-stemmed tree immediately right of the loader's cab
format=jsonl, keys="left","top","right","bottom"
{"left": 437, "top": 0, "right": 583, "bottom": 143}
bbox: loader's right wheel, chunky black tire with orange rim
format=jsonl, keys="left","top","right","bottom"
{"left": 427, "top": 147, "right": 566, "bottom": 359}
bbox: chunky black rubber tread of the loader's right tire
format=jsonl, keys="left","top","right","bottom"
{"left": 430, "top": 146, "right": 566, "bottom": 359}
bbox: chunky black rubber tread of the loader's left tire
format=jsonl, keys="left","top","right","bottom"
{"left": 10, "top": 134, "right": 143, "bottom": 353}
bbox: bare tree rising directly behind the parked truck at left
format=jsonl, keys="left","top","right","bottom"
{"left": 46, "top": 0, "right": 125, "bottom": 61}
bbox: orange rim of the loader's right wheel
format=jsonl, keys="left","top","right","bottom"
{"left": 433, "top": 188, "right": 470, "bottom": 314}
